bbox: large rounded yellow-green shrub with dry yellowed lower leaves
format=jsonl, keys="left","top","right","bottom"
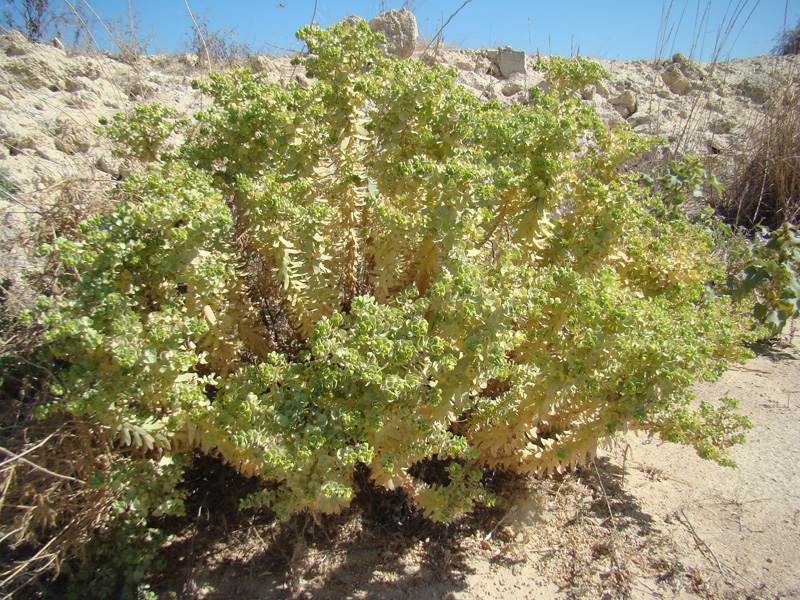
{"left": 31, "top": 25, "right": 749, "bottom": 519}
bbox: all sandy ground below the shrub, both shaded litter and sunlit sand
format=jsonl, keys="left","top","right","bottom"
{"left": 166, "top": 334, "right": 800, "bottom": 600}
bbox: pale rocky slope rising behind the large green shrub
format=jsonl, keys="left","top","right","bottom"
{"left": 0, "top": 25, "right": 800, "bottom": 191}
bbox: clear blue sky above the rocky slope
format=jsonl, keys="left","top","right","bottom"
{"left": 29, "top": 0, "right": 800, "bottom": 60}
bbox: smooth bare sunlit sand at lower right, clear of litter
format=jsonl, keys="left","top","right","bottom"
{"left": 626, "top": 335, "right": 800, "bottom": 598}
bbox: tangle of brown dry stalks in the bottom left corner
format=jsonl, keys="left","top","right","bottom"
{"left": 0, "top": 414, "right": 114, "bottom": 597}
